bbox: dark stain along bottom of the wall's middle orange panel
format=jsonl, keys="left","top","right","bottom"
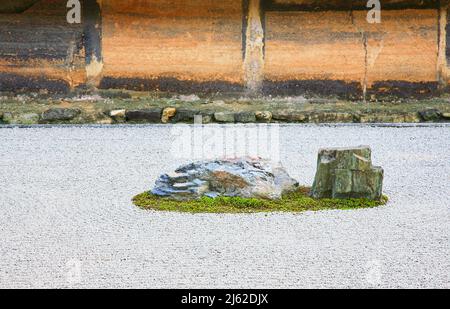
{"left": 99, "top": 77, "right": 244, "bottom": 94}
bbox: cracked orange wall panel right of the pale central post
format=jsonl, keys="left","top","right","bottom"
{"left": 265, "top": 9, "right": 438, "bottom": 92}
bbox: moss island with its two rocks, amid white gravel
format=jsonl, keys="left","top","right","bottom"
{"left": 134, "top": 146, "right": 387, "bottom": 213}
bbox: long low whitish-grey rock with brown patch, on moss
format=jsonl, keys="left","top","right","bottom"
{"left": 152, "top": 159, "right": 298, "bottom": 200}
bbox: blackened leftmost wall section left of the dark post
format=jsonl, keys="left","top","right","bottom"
{"left": 0, "top": 0, "right": 85, "bottom": 92}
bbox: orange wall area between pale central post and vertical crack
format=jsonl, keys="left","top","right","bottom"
{"left": 265, "top": 12, "right": 365, "bottom": 82}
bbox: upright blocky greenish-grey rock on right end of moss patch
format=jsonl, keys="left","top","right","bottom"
{"left": 311, "top": 146, "right": 384, "bottom": 200}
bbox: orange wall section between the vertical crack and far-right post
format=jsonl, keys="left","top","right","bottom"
{"left": 354, "top": 10, "right": 438, "bottom": 86}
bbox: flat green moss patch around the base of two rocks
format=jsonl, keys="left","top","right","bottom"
{"left": 133, "top": 188, "right": 388, "bottom": 213}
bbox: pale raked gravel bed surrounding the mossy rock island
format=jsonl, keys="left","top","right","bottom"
{"left": 0, "top": 125, "right": 450, "bottom": 288}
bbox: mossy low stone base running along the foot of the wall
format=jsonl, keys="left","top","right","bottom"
{"left": 0, "top": 91, "right": 450, "bottom": 125}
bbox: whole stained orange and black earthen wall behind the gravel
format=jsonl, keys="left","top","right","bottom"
{"left": 0, "top": 0, "right": 450, "bottom": 99}
